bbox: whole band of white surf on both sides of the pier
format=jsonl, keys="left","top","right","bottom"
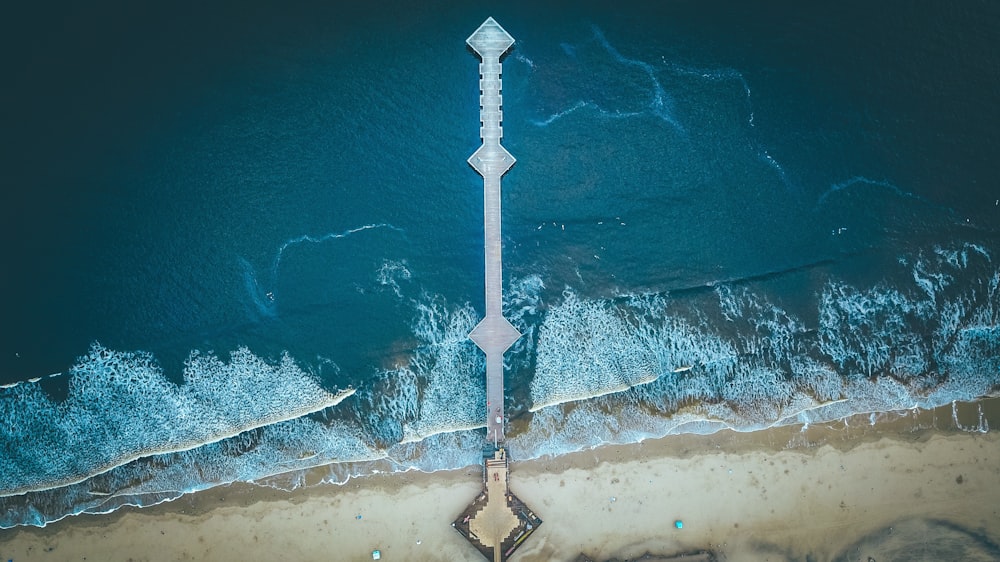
{"left": 0, "top": 244, "right": 1000, "bottom": 528}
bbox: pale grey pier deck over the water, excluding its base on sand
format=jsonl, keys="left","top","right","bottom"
{"left": 466, "top": 18, "right": 521, "bottom": 446}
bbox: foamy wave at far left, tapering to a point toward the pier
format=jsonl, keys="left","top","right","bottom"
{"left": 0, "top": 344, "right": 353, "bottom": 496}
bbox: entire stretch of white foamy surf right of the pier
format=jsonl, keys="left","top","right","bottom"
{"left": 511, "top": 244, "right": 1000, "bottom": 458}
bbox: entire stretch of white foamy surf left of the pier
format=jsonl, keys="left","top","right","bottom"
{"left": 0, "top": 295, "right": 486, "bottom": 528}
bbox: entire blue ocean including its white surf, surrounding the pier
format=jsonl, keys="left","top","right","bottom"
{"left": 0, "top": 0, "right": 1000, "bottom": 528}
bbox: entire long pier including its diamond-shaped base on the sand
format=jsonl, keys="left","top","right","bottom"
{"left": 451, "top": 18, "right": 542, "bottom": 561}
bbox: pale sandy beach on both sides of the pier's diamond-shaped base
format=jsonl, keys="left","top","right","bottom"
{"left": 0, "top": 401, "right": 1000, "bottom": 562}
